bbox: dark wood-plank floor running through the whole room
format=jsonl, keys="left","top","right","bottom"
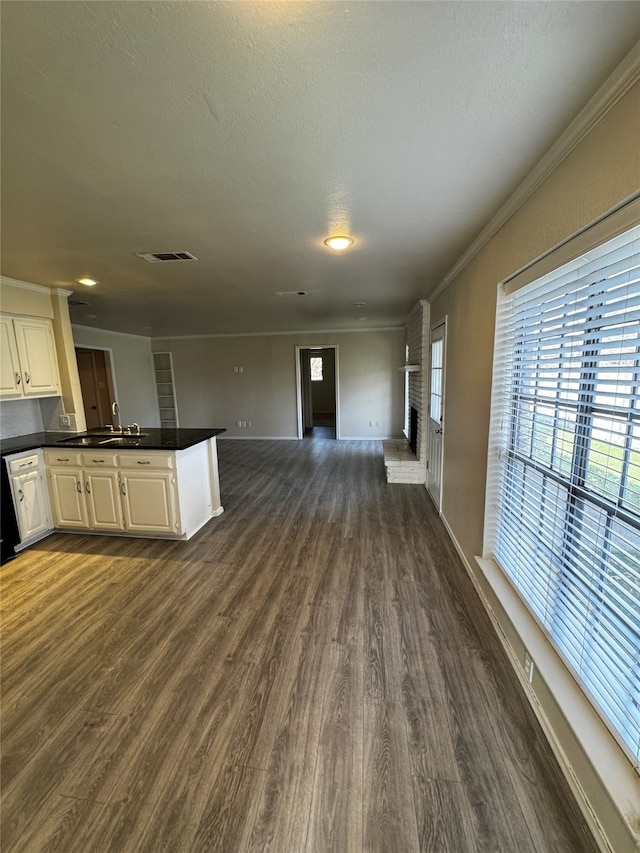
{"left": 0, "top": 439, "right": 597, "bottom": 853}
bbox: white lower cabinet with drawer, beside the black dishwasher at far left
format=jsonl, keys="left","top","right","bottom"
{"left": 6, "top": 450, "right": 52, "bottom": 550}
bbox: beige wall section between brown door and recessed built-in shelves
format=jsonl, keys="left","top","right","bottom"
{"left": 72, "top": 325, "right": 160, "bottom": 427}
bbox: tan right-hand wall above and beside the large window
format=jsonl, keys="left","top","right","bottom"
{"left": 431, "top": 83, "right": 640, "bottom": 562}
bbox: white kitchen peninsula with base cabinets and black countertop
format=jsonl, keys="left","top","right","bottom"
{"left": 2, "top": 427, "right": 225, "bottom": 549}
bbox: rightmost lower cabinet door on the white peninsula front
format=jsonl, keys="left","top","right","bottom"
{"left": 120, "top": 470, "right": 179, "bottom": 533}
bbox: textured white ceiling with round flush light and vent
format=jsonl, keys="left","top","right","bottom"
{"left": 1, "top": 0, "right": 640, "bottom": 335}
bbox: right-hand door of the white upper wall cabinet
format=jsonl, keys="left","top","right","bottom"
{"left": 13, "top": 317, "right": 60, "bottom": 397}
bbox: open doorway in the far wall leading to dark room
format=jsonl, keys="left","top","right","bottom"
{"left": 296, "top": 346, "right": 340, "bottom": 439}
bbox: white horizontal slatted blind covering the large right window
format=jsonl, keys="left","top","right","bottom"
{"left": 492, "top": 221, "right": 640, "bottom": 767}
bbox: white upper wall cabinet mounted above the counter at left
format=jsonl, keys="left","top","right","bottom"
{"left": 0, "top": 315, "right": 60, "bottom": 400}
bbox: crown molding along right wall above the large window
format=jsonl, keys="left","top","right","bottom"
{"left": 428, "top": 42, "right": 640, "bottom": 302}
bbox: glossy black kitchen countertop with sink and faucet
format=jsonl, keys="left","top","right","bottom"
{"left": 0, "top": 427, "right": 226, "bottom": 457}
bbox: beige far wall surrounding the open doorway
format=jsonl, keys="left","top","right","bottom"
{"left": 153, "top": 329, "right": 404, "bottom": 438}
